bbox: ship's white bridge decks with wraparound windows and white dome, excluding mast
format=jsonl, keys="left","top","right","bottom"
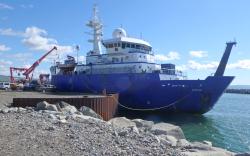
{"left": 87, "top": 28, "right": 155, "bottom": 64}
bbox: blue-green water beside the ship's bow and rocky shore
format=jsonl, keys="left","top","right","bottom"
{"left": 123, "top": 94, "right": 250, "bottom": 152}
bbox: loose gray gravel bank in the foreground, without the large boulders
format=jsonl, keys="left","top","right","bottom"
{"left": 0, "top": 111, "right": 184, "bottom": 156}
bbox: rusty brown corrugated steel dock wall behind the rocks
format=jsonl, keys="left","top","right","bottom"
{"left": 12, "top": 94, "right": 119, "bottom": 121}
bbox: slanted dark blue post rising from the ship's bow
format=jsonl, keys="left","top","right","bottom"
{"left": 214, "top": 42, "right": 237, "bottom": 76}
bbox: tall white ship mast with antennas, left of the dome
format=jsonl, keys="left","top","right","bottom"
{"left": 86, "top": 5, "right": 103, "bottom": 54}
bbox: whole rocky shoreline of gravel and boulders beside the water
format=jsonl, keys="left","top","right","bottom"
{"left": 0, "top": 102, "right": 249, "bottom": 156}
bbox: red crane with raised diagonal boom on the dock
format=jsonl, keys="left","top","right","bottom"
{"left": 10, "top": 46, "right": 57, "bottom": 83}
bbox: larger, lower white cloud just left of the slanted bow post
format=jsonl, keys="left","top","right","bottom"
{"left": 187, "top": 60, "right": 219, "bottom": 70}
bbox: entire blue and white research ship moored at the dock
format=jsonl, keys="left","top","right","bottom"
{"left": 50, "top": 7, "right": 236, "bottom": 114}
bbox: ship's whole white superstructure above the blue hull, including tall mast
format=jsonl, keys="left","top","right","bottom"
{"left": 51, "top": 6, "right": 187, "bottom": 80}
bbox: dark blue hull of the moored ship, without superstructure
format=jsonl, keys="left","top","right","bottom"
{"left": 51, "top": 73, "right": 234, "bottom": 114}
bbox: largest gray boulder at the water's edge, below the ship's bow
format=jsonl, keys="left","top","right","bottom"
{"left": 150, "top": 123, "right": 185, "bottom": 139}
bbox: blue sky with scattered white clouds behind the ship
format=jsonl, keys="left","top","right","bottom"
{"left": 0, "top": 0, "right": 250, "bottom": 84}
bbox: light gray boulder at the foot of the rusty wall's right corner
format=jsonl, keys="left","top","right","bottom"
{"left": 108, "top": 117, "right": 136, "bottom": 129}
